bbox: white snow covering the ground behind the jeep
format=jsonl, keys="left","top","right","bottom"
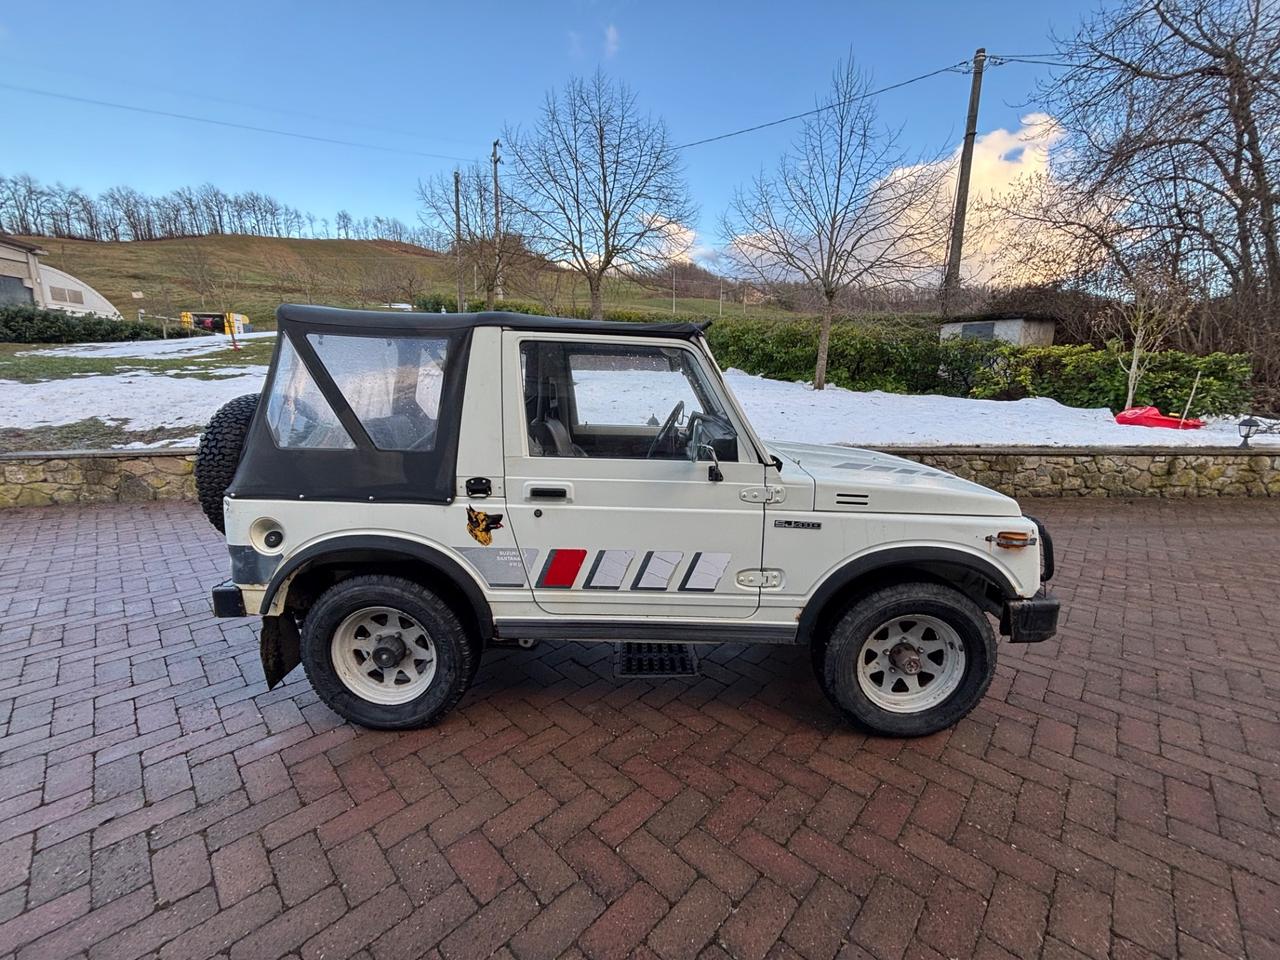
{"left": 0, "top": 363, "right": 1280, "bottom": 448}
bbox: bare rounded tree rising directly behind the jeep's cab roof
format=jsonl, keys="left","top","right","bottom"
{"left": 503, "top": 72, "right": 695, "bottom": 319}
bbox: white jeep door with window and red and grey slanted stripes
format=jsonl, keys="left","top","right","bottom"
{"left": 503, "top": 332, "right": 764, "bottom": 620}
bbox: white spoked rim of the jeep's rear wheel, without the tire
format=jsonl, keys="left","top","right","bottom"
{"left": 330, "top": 607, "right": 435, "bottom": 705}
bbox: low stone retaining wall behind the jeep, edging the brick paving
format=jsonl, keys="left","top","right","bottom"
{"left": 0, "top": 447, "right": 1280, "bottom": 507}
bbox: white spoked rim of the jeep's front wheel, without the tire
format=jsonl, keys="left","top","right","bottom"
{"left": 858, "top": 616, "right": 965, "bottom": 713}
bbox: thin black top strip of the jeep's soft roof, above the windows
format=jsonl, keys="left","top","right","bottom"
{"left": 275, "top": 303, "right": 710, "bottom": 339}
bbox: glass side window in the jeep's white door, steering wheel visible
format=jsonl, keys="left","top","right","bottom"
{"left": 521, "top": 340, "right": 724, "bottom": 460}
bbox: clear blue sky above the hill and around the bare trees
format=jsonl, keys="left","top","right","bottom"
{"left": 0, "top": 0, "right": 1096, "bottom": 243}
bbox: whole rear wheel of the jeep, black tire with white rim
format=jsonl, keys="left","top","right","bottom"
{"left": 301, "top": 576, "right": 476, "bottom": 730}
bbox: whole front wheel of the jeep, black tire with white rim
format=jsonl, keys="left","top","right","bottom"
{"left": 814, "top": 582, "right": 996, "bottom": 737}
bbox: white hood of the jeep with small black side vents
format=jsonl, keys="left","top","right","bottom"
{"left": 767, "top": 442, "right": 1021, "bottom": 517}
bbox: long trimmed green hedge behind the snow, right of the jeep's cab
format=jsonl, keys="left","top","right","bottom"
{"left": 708, "top": 320, "right": 1252, "bottom": 416}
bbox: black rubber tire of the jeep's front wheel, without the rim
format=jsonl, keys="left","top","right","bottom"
{"left": 814, "top": 582, "right": 996, "bottom": 737}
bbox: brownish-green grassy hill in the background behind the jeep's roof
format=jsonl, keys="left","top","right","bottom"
{"left": 27, "top": 237, "right": 803, "bottom": 329}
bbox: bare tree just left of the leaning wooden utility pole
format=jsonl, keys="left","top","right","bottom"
{"left": 723, "top": 59, "right": 946, "bottom": 390}
